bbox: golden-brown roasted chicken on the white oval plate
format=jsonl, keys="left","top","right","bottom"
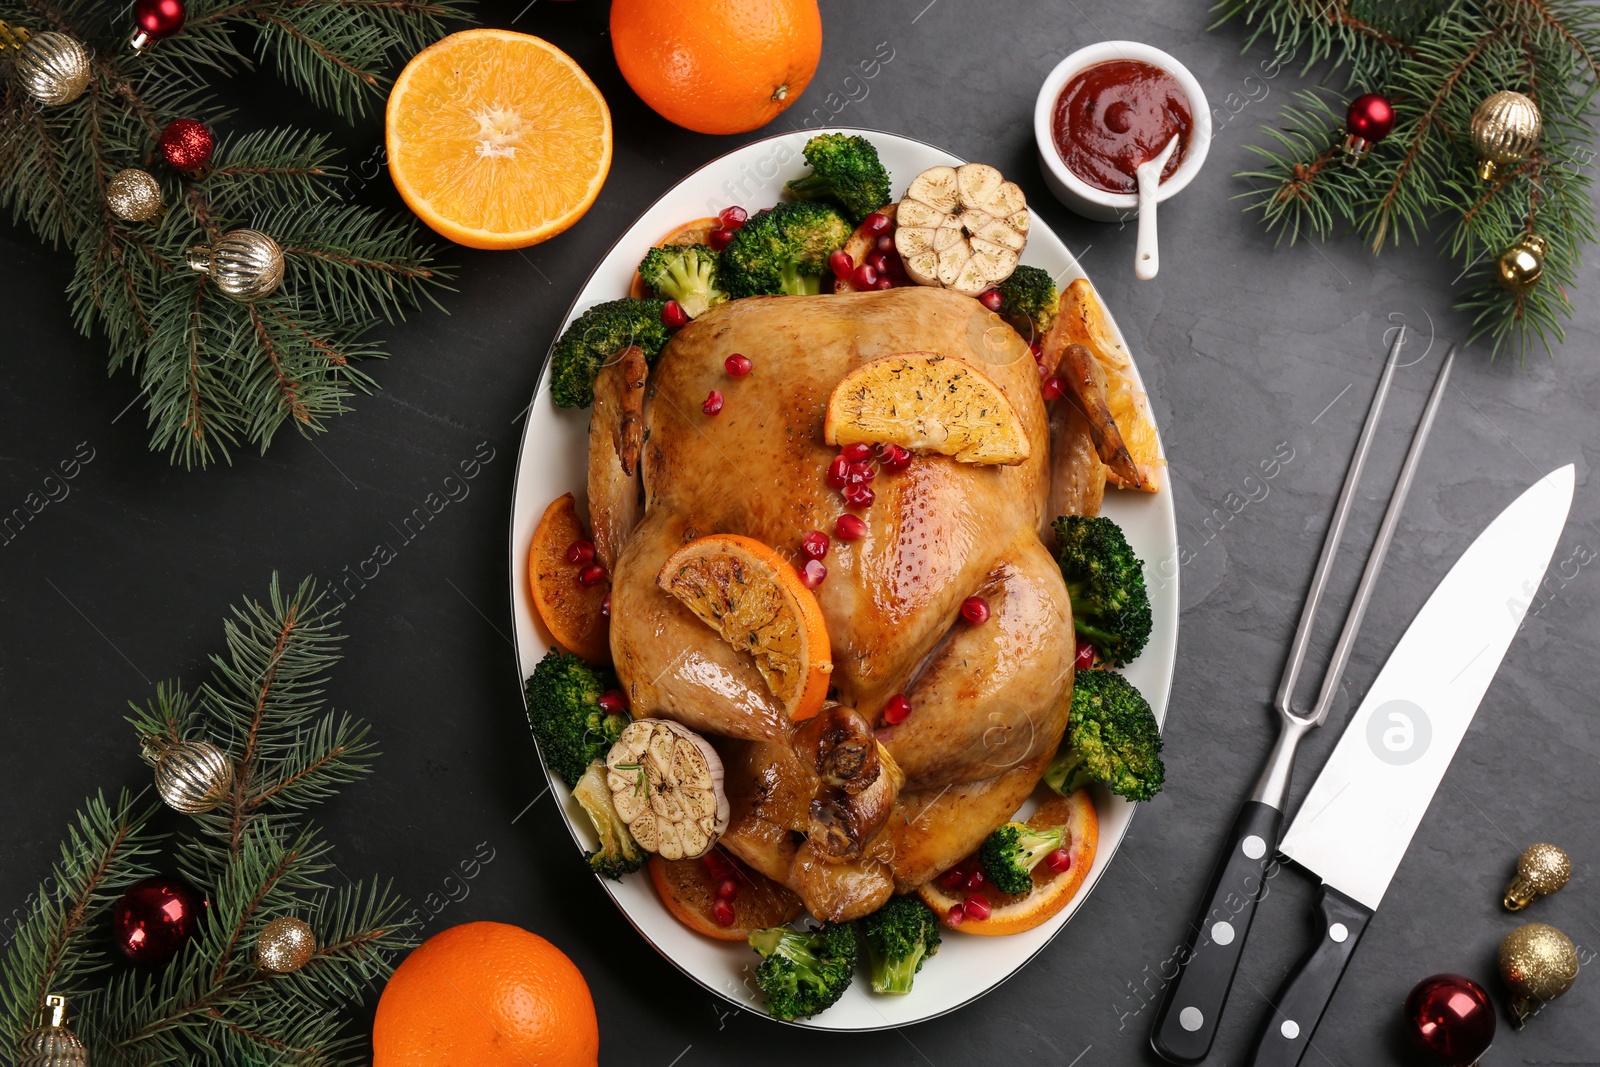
{"left": 611, "top": 286, "right": 1074, "bottom": 917}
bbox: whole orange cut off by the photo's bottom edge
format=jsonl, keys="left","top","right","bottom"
{"left": 373, "top": 923, "right": 600, "bottom": 1067}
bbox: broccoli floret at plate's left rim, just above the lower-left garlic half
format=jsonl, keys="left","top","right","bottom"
{"left": 528, "top": 648, "right": 630, "bottom": 785}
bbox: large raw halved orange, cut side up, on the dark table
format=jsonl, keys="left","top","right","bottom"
{"left": 384, "top": 29, "right": 611, "bottom": 248}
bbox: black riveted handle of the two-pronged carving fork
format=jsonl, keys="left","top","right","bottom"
{"left": 1150, "top": 800, "right": 1283, "bottom": 1064}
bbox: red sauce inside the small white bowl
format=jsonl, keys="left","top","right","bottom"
{"left": 1051, "top": 59, "right": 1194, "bottom": 192}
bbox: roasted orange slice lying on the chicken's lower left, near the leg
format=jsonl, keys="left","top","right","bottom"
{"left": 656, "top": 534, "right": 834, "bottom": 720}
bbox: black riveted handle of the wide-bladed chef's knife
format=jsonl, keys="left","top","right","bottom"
{"left": 1250, "top": 885, "right": 1373, "bottom": 1067}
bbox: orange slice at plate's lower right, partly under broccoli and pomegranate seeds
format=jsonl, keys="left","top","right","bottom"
{"left": 917, "top": 789, "right": 1099, "bottom": 937}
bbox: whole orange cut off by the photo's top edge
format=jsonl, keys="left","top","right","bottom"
{"left": 611, "top": 0, "right": 822, "bottom": 133}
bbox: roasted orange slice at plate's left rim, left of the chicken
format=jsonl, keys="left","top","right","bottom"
{"left": 528, "top": 493, "right": 611, "bottom": 664}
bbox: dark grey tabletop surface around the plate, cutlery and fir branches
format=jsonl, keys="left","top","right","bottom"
{"left": 0, "top": 0, "right": 1600, "bottom": 1067}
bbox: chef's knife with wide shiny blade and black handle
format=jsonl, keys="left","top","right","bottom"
{"left": 1251, "top": 466, "right": 1574, "bottom": 1067}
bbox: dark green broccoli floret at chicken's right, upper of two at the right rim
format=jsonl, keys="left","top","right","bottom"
{"left": 1056, "top": 515, "right": 1150, "bottom": 665}
